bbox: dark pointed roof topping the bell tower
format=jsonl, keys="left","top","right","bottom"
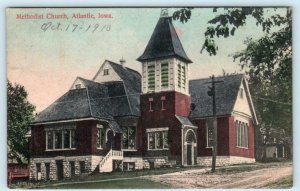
{"left": 137, "top": 17, "right": 192, "bottom": 63}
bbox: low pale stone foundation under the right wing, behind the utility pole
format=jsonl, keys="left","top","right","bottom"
{"left": 197, "top": 156, "right": 255, "bottom": 166}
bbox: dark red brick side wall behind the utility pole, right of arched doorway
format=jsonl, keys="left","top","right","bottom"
{"left": 193, "top": 117, "right": 229, "bottom": 157}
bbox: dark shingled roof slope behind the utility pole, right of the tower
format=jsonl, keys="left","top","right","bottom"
{"left": 189, "top": 74, "right": 243, "bottom": 118}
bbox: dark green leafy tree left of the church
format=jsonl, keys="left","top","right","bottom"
{"left": 7, "top": 81, "right": 35, "bottom": 163}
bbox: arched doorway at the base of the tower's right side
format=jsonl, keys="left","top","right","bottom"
{"left": 185, "top": 129, "right": 197, "bottom": 165}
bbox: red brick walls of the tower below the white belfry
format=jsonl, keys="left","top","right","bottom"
{"left": 138, "top": 91, "right": 191, "bottom": 158}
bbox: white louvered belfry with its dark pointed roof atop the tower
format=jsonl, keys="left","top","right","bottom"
{"left": 137, "top": 15, "right": 192, "bottom": 94}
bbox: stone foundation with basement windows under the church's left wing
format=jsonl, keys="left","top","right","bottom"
{"left": 29, "top": 156, "right": 103, "bottom": 180}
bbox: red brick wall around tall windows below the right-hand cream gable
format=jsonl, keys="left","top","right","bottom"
{"left": 229, "top": 116, "right": 254, "bottom": 158}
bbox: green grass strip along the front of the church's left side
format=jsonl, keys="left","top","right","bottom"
{"left": 11, "top": 167, "right": 190, "bottom": 188}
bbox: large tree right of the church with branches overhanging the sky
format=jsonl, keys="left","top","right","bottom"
{"left": 173, "top": 7, "right": 292, "bottom": 159}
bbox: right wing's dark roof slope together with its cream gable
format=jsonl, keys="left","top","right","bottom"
{"left": 189, "top": 74, "right": 258, "bottom": 124}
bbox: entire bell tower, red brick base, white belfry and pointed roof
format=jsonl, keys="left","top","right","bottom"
{"left": 137, "top": 9, "right": 197, "bottom": 166}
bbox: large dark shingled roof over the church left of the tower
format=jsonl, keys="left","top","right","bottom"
{"left": 33, "top": 62, "right": 141, "bottom": 126}
